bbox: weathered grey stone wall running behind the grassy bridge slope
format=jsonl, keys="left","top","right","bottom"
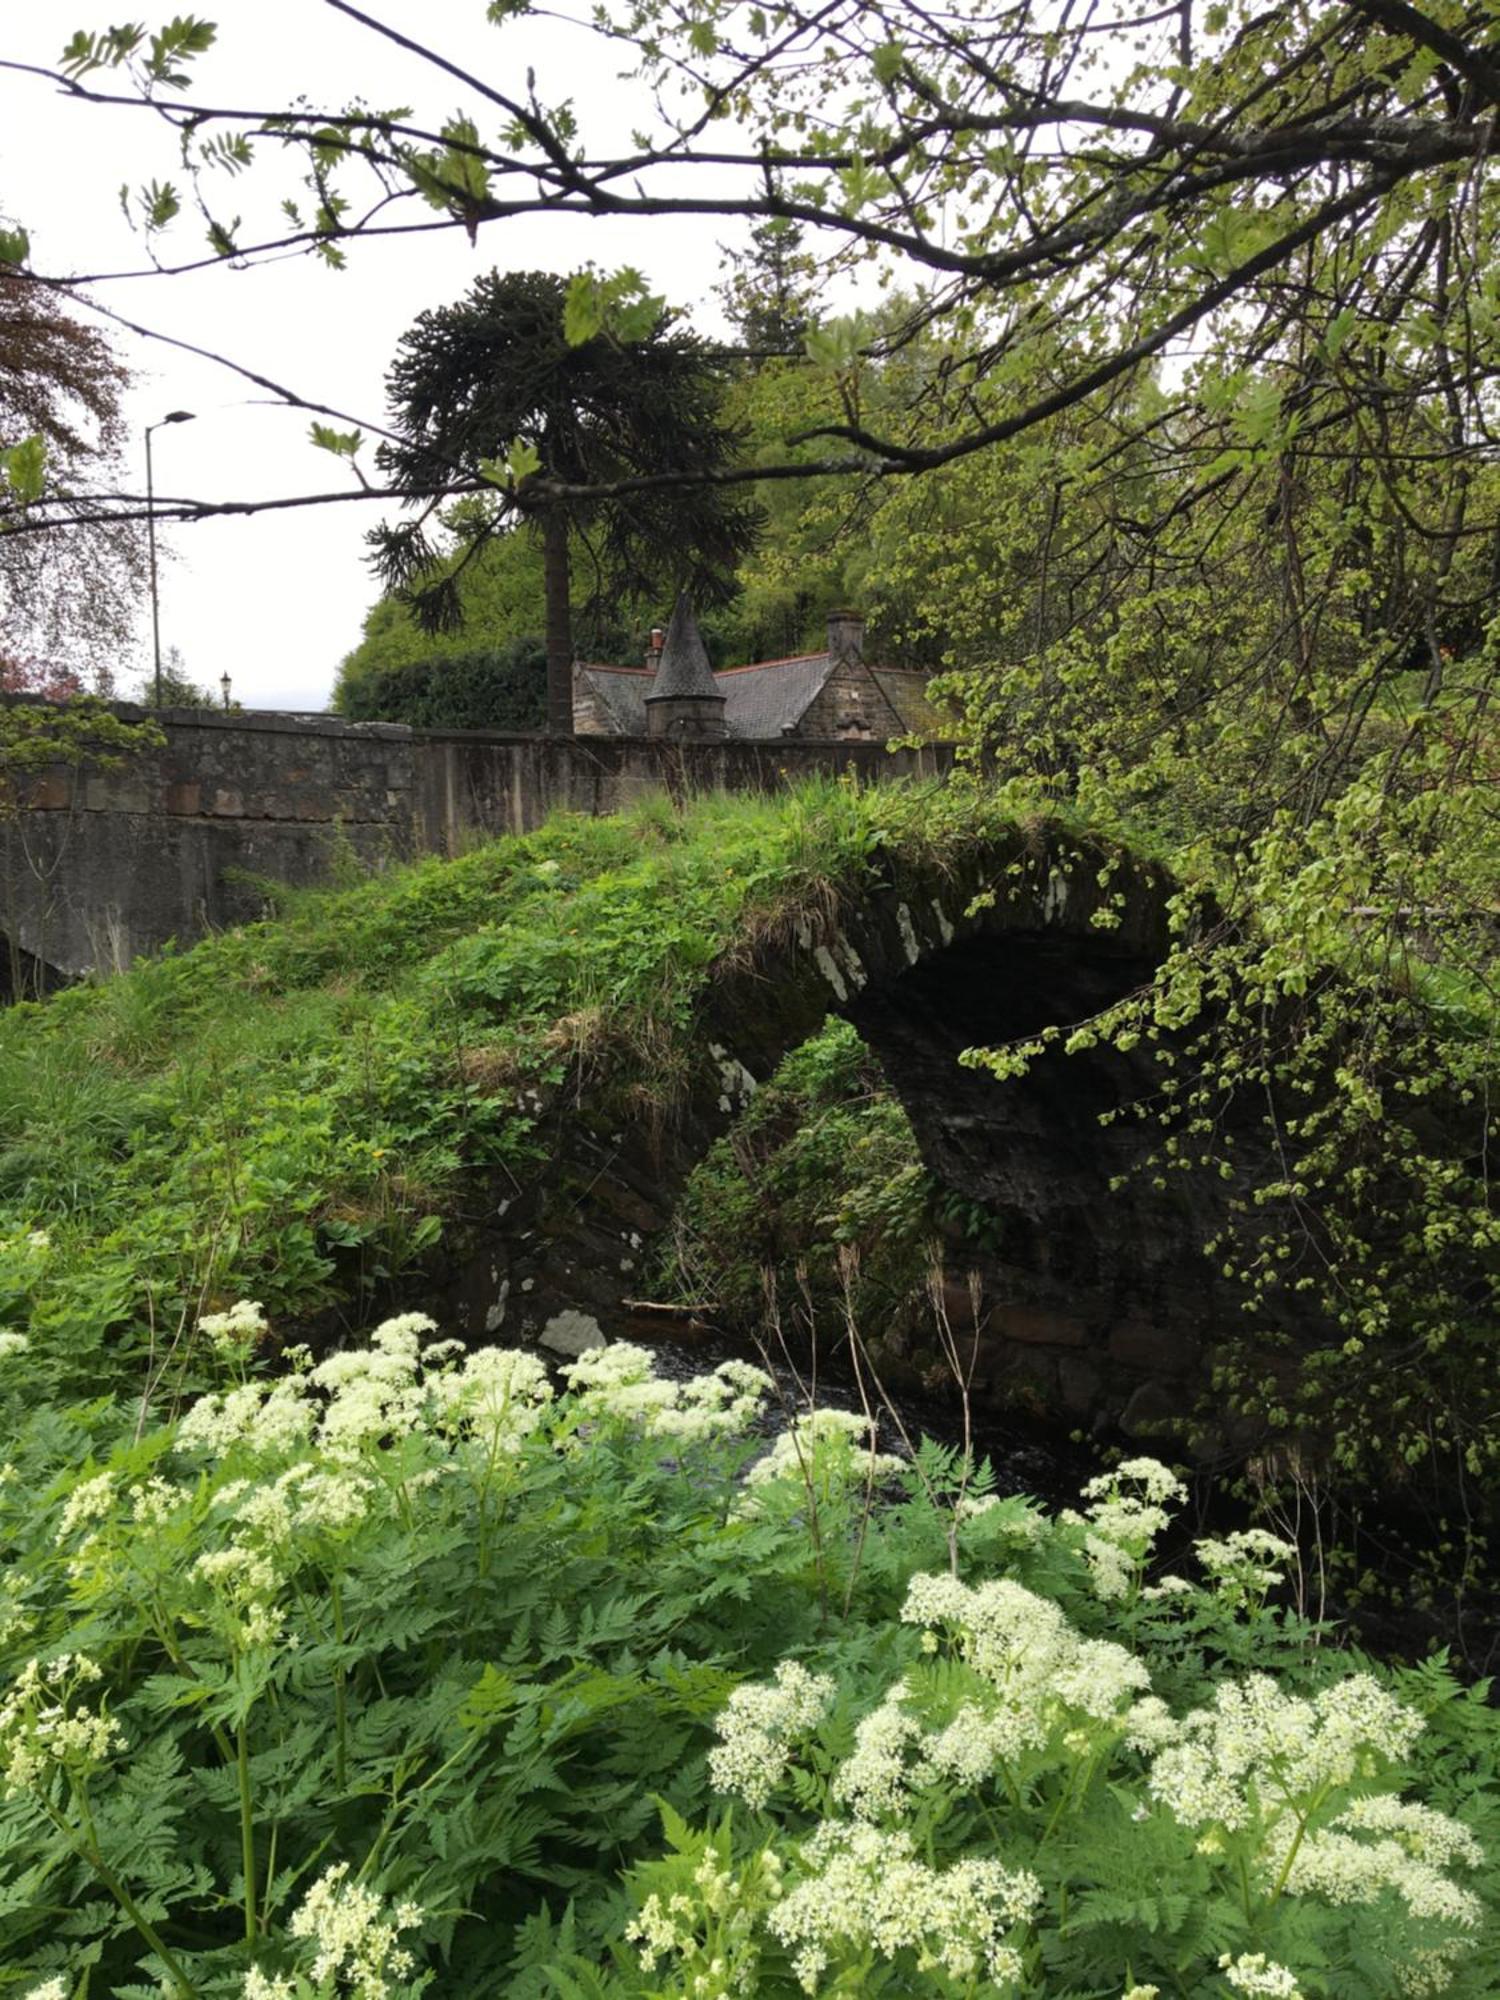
{"left": 0, "top": 704, "right": 952, "bottom": 978}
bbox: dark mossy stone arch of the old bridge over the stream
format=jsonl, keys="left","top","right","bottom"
{"left": 446, "top": 834, "right": 1296, "bottom": 1436}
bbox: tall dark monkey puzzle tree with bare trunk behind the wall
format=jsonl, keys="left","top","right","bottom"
{"left": 370, "top": 272, "right": 758, "bottom": 736}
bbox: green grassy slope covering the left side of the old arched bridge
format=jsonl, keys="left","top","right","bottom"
{"left": 0, "top": 784, "right": 890, "bottom": 1390}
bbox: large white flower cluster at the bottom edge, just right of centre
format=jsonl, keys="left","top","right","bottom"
{"left": 766, "top": 1820, "right": 1042, "bottom": 1994}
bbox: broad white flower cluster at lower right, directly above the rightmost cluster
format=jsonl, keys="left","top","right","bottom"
{"left": 1150, "top": 1674, "right": 1422, "bottom": 1828}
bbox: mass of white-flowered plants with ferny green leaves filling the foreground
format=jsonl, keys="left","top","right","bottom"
{"left": 0, "top": 1304, "right": 1500, "bottom": 2000}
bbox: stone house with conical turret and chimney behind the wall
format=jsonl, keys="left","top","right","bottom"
{"left": 572, "top": 598, "right": 948, "bottom": 742}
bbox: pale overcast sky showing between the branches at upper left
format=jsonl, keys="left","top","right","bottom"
{"left": 0, "top": 0, "right": 748, "bottom": 708}
